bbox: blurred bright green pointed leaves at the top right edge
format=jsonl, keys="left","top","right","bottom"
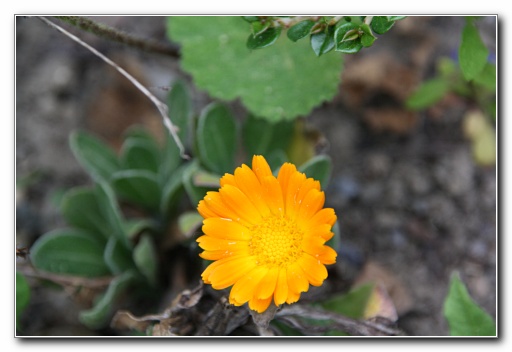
{"left": 406, "top": 18, "right": 496, "bottom": 119}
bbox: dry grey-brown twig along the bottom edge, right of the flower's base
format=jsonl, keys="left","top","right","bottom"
{"left": 276, "top": 305, "right": 403, "bottom": 336}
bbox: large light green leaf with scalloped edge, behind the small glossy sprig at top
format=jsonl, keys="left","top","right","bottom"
{"left": 168, "top": 16, "right": 342, "bottom": 121}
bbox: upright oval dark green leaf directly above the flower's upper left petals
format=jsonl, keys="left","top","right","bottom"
{"left": 197, "top": 103, "right": 237, "bottom": 174}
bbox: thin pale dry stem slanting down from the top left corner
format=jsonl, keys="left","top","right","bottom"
{"left": 38, "top": 17, "right": 190, "bottom": 160}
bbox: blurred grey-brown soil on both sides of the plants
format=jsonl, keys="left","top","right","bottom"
{"left": 16, "top": 17, "right": 497, "bottom": 336}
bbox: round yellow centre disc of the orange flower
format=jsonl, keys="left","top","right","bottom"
{"left": 249, "top": 215, "right": 303, "bottom": 267}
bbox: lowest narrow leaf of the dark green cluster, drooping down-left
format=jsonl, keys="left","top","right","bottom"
{"left": 79, "top": 271, "right": 137, "bottom": 329}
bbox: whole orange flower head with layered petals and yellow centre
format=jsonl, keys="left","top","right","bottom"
{"left": 197, "top": 155, "right": 336, "bottom": 313}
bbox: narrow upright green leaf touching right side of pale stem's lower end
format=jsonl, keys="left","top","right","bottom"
{"left": 166, "top": 80, "right": 192, "bottom": 151}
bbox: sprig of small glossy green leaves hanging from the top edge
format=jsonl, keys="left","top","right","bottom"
{"left": 244, "top": 16, "right": 405, "bottom": 56}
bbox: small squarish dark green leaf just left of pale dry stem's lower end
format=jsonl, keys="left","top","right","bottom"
{"left": 121, "top": 138, "right": 161, "bottom": 173}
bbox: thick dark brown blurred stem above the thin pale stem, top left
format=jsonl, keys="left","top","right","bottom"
{"left": 54, "top": 16, "right": 180, "bottom": 58}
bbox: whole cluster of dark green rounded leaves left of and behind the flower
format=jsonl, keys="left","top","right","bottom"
{"left": 28, "top": 82, "right": 331, "bottom": 329}
